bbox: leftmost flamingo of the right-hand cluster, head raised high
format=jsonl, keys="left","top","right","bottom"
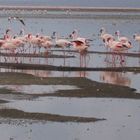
{"left": 100, "top": 27, "right": 114, "bottom": 47}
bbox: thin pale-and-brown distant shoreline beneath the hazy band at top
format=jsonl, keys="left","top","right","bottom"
{"left": 0, "top": 5, "right": 140, "bottom": 12}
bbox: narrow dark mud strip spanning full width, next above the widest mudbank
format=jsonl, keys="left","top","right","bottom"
{"left": 0, "top": 62, "right": 140, "bottom": 73}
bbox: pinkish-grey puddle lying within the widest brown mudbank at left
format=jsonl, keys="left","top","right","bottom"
{"left": 0, "top": 85, "right": 79, "bottom": 94}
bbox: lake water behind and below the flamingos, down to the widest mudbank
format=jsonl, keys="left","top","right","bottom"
{"left": 0, "top": 13, "right": 140, "bottom": 91}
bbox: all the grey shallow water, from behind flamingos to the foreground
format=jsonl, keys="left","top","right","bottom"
{"left": 0, "top": 10, "right": 140, "bottom": 140}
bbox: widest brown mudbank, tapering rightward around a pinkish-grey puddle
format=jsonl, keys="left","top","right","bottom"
{"left": 0, "top": 73, "right": 140, "bottom": 99}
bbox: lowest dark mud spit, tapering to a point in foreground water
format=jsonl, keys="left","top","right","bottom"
{"left": 0, "top": 109, "right": 105, "bottom": 123}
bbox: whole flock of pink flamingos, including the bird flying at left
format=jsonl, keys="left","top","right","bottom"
{"left": 0, "top": 17, "right": 140, "bottom": 65}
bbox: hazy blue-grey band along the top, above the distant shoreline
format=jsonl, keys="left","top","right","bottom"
{"left": 0, "top": 0, "right": 140, "bottom": 7}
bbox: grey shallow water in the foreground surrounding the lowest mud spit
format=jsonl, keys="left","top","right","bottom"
{"left": 0, "top": 97, "right": 140, "bottom": 140}
